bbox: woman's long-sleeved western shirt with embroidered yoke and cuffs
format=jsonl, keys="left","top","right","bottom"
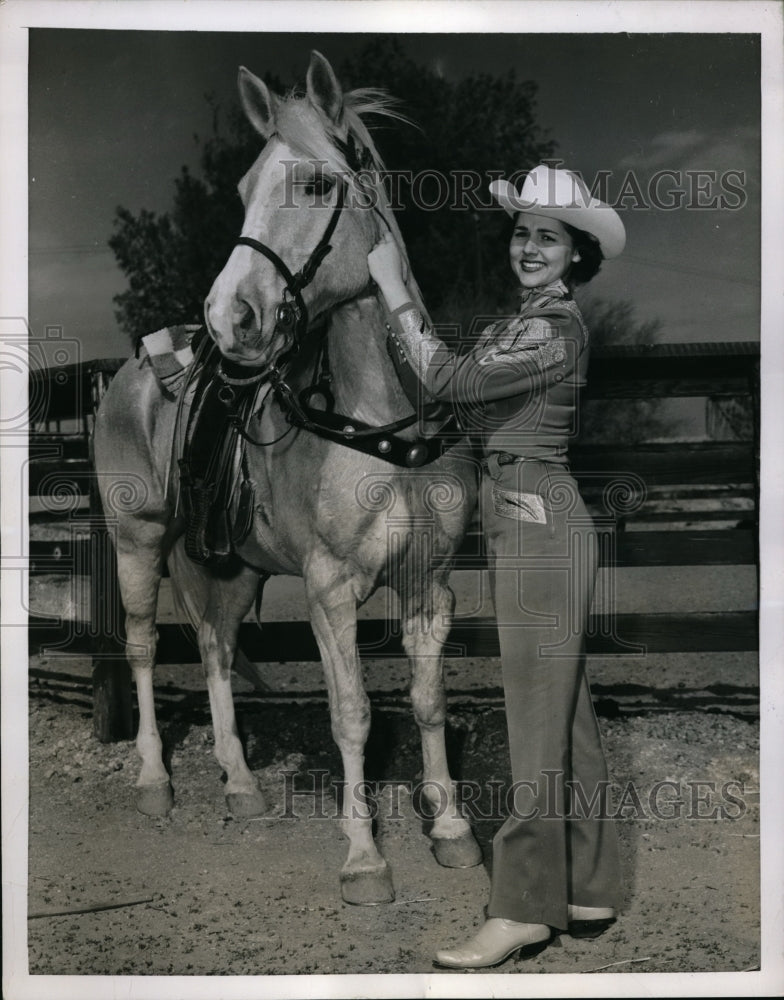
{"left": 390, "top": 281, "right": 588, "bottom": 463}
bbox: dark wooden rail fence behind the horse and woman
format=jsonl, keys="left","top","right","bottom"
{"left": 29, "top": 343, "right": 759, "bottom": 741}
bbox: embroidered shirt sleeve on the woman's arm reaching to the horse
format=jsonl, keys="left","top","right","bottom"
{"left": 390, "top": 303, "right": 583, "bottom": 403}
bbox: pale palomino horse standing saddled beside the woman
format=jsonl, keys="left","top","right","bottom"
{"left": 94, "top": 52, "right": 481, "bottom": 903}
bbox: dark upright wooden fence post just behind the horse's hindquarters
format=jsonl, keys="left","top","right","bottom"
{"left": 90, "top": 367, "right": 133, "bottom": 743}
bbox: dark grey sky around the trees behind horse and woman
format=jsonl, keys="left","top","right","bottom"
{"left": 21, "top": 21, "right": 761, "bottom": 358}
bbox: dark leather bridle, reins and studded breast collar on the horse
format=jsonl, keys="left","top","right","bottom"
{"left": 217, "top": 141, "right": 457, "bottom": 468}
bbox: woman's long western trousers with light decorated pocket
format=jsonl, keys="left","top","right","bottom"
{"left": 482, "top": 457, "right": 620, "bottom": 930}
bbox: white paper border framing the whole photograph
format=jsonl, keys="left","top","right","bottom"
{"left": 0, "top": 0, "right": 784, "bottom": 1000}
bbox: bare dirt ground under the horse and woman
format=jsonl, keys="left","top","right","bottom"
{"left": 23, "top": 658, "right": 760, "bottom": 984}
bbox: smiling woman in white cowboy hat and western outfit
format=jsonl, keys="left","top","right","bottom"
{"left": 368, "top": 165, "right": 626, "bottom": 969}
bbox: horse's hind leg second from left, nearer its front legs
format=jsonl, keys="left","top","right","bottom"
{"left": 198, "top": 567, "right": 265, "bottom": 817}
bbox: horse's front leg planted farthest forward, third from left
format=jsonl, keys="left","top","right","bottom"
{"left": 305, "top": 560, "right": 395, "bottom": 906}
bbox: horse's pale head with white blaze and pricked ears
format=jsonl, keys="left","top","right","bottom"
{"left": 205, "top": 52, "right": 410, "bottom": 366}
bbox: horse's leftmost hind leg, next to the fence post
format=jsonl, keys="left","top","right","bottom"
{"left": 117, "top": 522, "right": 173, "bottom": 816}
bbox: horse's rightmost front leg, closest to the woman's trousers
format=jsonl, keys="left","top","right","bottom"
{"left": 401, "top": 580, "right": 482, "bottom": 868}
